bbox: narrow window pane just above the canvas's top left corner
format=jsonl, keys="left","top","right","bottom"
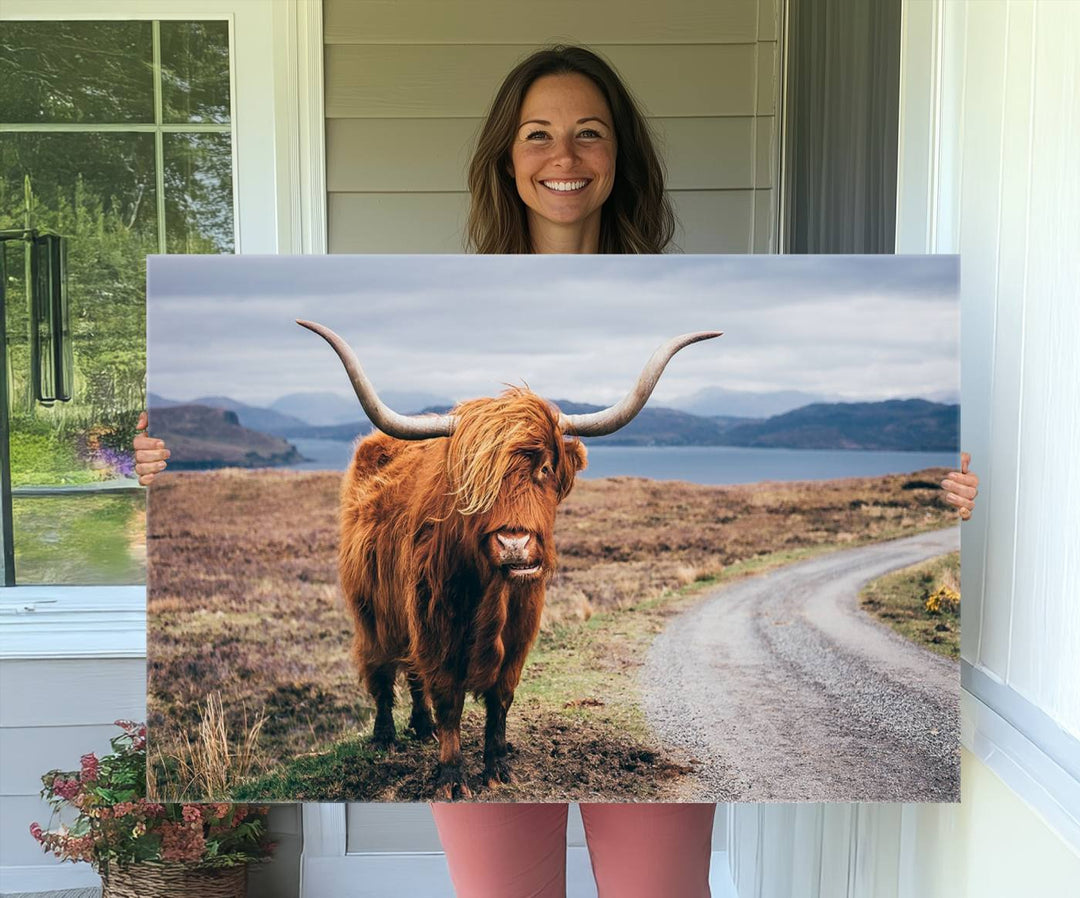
{"left": 164, "top": 134, "right": 233, "bottom": 253}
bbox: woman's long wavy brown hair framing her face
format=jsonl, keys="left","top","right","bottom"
{"left": 468, "top": 46, "right": 675, "bottom": 253}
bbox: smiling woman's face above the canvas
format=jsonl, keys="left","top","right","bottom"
{"left": 510, "top": 75, "right": 616, "bottom": 238}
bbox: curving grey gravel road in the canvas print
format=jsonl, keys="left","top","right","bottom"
{"left": 642, "top": 527, "right": 960, "bottom": 802}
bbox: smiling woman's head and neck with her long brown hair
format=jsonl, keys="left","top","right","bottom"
{"left": 468, "top": 46, "right": 675, "bottom": 253}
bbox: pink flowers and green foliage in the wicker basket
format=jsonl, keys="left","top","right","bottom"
{"left": 30, "top": 721, "right": 273, "bottom": 876}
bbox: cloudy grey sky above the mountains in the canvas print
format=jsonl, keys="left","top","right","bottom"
{"left": 148, "top": 255, "right": 959, "bottom": 405}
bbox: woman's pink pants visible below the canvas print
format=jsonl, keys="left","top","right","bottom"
{"left": 431, "top": 804, "right": 716, "bottom": 898}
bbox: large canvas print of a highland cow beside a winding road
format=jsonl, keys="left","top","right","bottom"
{"left": 147, "top": 250, "right": 960, "bottom": 802}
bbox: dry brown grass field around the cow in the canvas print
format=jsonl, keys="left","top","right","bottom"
{"left": 148, "top": 469, "right": 955, "bottom": 801}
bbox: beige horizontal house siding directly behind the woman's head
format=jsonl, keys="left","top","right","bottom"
{"left": 324, "top": 0, "right": 780, "bottom": 253}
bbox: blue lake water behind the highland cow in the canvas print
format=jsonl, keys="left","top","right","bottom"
{"left": 291, "top": 440, "right": 959, "bottom": 484}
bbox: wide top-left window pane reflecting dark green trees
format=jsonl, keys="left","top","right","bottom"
{"left": 0, "top": 22, "right": 153, "bottom": 123}
